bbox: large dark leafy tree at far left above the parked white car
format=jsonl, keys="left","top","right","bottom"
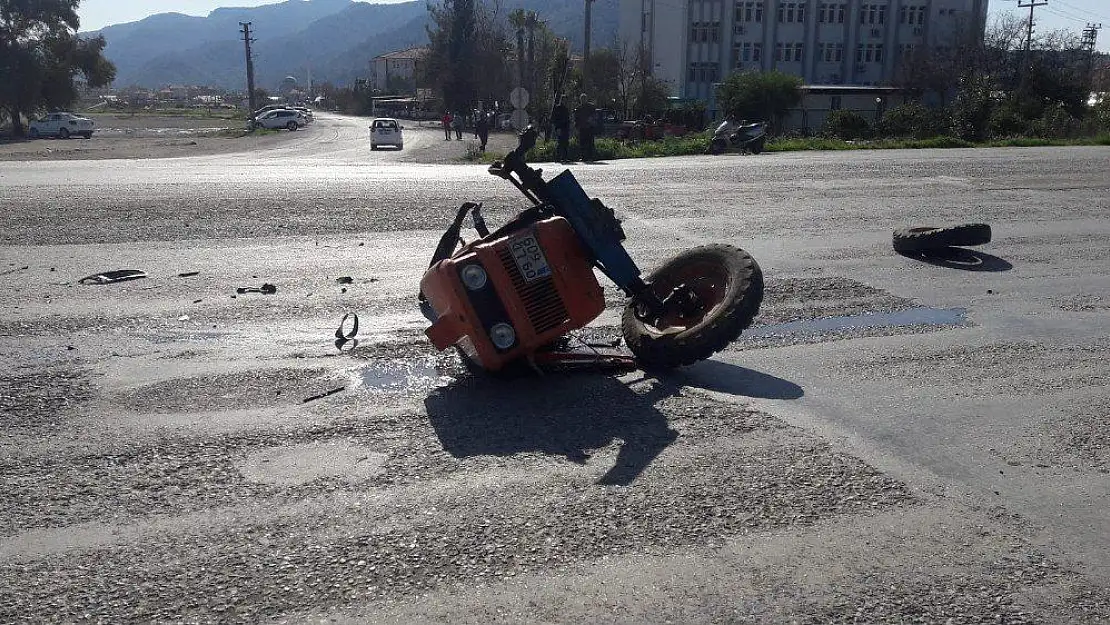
{"left": 0, "top": 0, "right": 115, "bottom": 137}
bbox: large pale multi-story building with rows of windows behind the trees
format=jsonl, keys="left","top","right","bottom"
{"left": 620, "top": 0, "right": 987, "bottom": 110}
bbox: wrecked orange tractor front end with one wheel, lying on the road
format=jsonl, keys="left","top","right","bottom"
{"left": 421, "top": 127, "right": 764, "bottom": 371}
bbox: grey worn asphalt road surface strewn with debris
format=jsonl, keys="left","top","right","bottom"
{"left": 0, "top": 117, "right": 1110, "bottom": 624}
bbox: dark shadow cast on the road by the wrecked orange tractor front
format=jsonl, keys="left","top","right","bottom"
{"left": 424, "top": 362, "right": 803, "bottom": 485}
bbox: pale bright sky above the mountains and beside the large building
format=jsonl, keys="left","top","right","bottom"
{"left": 79, "top": 0, "right": 1110, "bottom": 52}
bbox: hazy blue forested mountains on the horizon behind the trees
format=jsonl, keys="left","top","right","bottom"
{"left": 82, "top": 0, "right": 618, "bottom": 90}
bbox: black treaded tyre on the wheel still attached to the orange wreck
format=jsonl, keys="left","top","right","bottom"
{"left": 620, "top": 245, "right": 764, "bottom": 370}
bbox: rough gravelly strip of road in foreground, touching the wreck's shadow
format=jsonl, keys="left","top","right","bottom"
{"left": 0, "top": 402, "right": 915, "bottom": 623}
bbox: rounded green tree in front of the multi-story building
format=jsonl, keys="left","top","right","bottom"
{"left": 717, "top": 71, "right": 801, "bottom": 127}
